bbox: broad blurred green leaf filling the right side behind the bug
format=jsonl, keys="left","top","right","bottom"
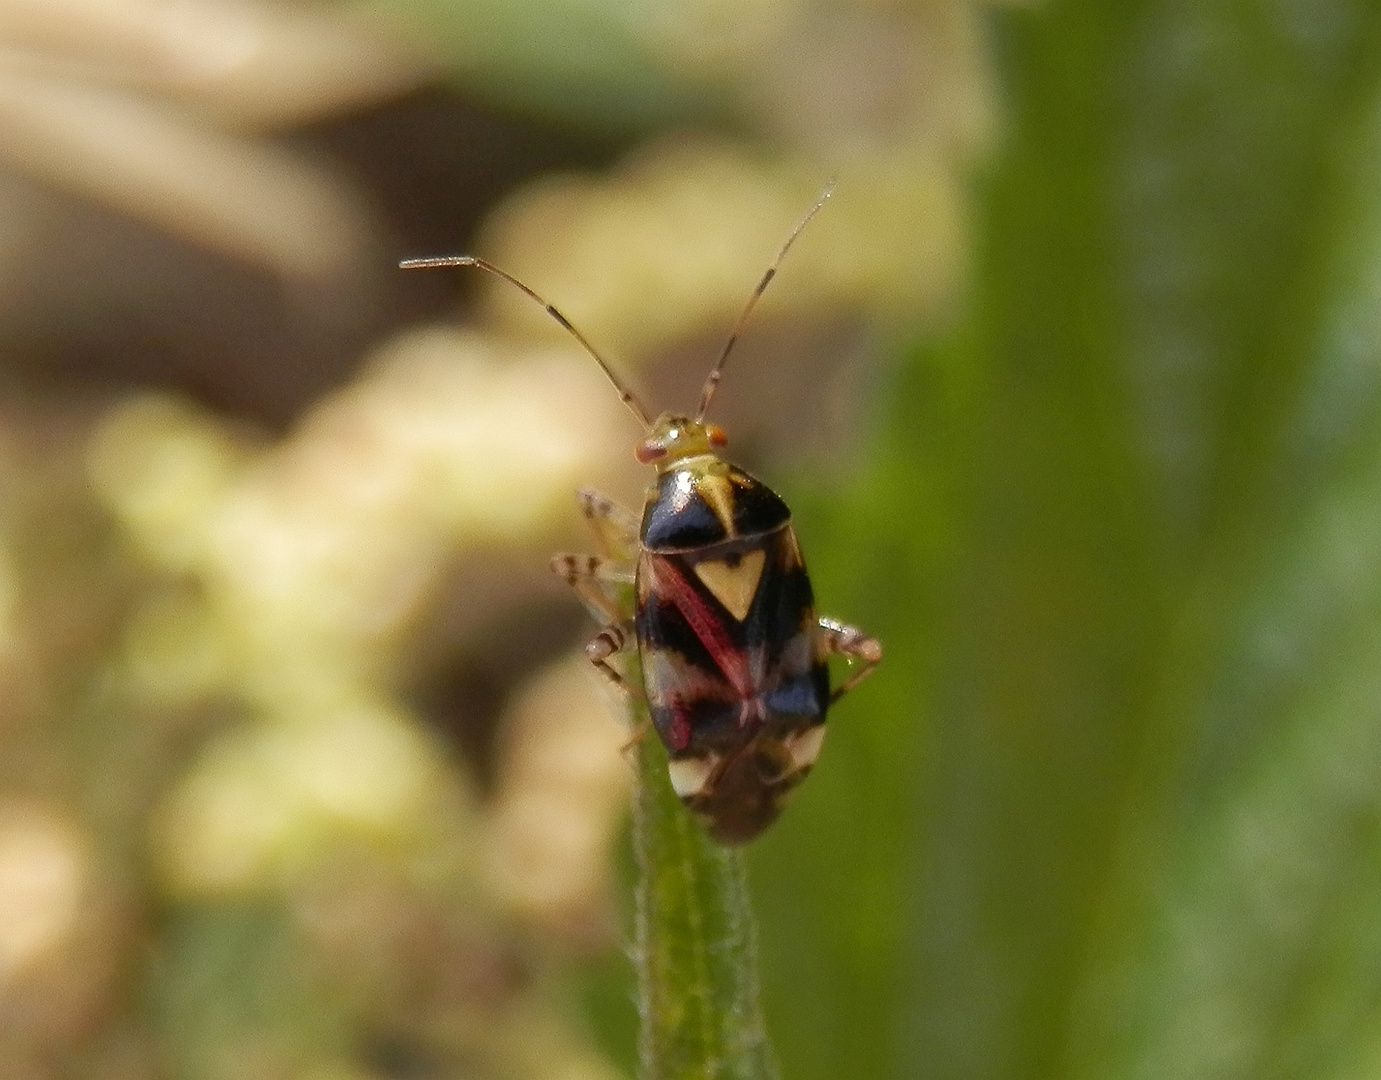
{"left": 754, "top": 0, "right": 1381, "bottom": 1079}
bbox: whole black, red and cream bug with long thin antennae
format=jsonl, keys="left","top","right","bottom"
{"left": 400, "top": 184, "right": 882, "bottom": 844}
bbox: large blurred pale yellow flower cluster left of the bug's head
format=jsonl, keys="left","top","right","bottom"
{"left": 91, "top": 330, "right": 619, "bottom": 706}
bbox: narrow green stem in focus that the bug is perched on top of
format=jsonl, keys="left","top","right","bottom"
{"left": 631, "top": 690, "right": 778, "bottom": 1080}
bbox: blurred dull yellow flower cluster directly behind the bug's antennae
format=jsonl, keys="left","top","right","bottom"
{"left": 479, "top": 137, "right": 964, "bottom": 372}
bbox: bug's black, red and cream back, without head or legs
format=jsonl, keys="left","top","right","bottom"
{"left": 637, "top": 456, "right": 830, "bottom": 842}
